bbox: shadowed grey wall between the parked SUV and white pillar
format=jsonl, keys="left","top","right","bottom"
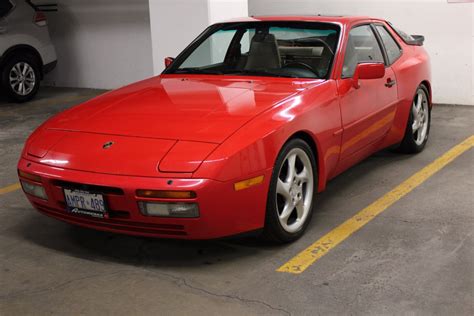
{"left": 45, "top": 0, "right": 153, "bottom": 89}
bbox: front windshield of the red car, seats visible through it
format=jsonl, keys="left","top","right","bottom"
{"left": 164, "top": 22, "right": 340, "bottom": 79}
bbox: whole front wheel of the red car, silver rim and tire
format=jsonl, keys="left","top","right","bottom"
{"left": 263, "top": 139, "right": 318, "bottom": 243}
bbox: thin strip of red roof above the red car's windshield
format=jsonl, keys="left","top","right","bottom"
{"left": 220, "top": 14, "right": 383, "bottom": 24}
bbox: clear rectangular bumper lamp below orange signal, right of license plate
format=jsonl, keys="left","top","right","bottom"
{"left": 138, "top": 202, "right": 199, "bottom": 218}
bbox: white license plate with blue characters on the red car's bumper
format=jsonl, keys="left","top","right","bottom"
{"left": 64, "top": 189, "right": 106, "bottom": 218}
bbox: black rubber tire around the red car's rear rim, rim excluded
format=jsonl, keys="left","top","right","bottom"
{"left": 395, "top": 85, "right": 431, "bottom": 154}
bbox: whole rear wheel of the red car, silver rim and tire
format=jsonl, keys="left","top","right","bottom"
{"left": 396, "top": 85, "right": 431, "bottom": 154}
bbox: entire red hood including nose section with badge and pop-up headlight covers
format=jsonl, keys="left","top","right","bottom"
{"left": 23, "top": 77, "right": 322, "bottom": 177}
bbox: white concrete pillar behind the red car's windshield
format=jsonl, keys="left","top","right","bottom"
{"left": 149, "top": 0, "right": 248, "bottom": 75}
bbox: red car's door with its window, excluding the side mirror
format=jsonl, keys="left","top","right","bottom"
{"left": 338, "top": 24, "right": 397, "bottom": 160}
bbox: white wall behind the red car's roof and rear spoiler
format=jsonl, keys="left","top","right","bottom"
{"left": 249, "top": 0, "right": 474, "bottom": 105}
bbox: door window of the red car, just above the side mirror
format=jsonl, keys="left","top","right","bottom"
{"left": 342, "top": 25, "right": 384, "bottom": 78}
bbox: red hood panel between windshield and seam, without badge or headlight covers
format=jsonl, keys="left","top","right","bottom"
{"left": 45, "top": 75, "right": 314, "bottom": 143}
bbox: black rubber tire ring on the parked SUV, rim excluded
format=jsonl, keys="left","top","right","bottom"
{"left": 1, "top": 53, "right": 41, "bottom": 103}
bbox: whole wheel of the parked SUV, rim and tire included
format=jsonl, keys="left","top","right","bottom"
{"left": 1, "top": 54, "right": 41, "bottom": 103}
